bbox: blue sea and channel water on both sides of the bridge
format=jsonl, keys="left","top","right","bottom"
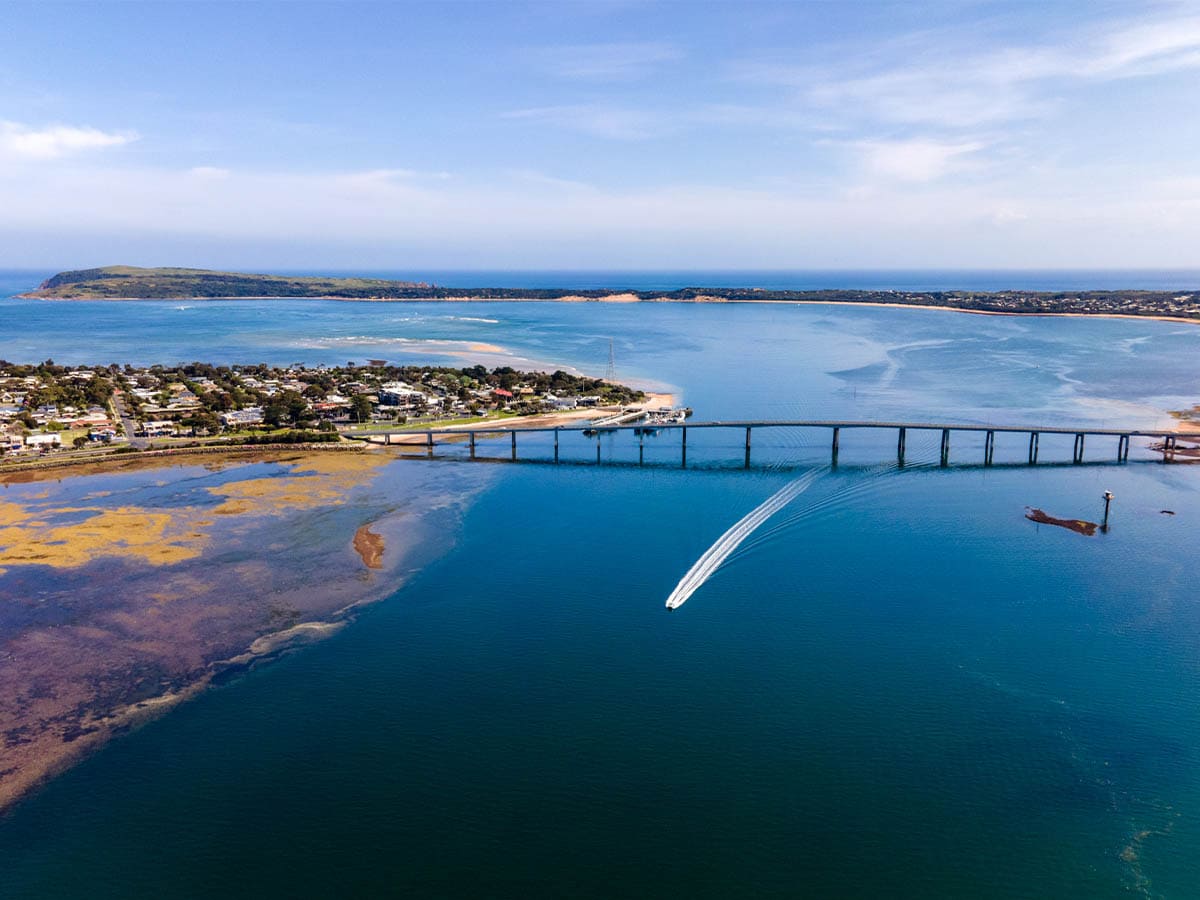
{"left": 0, "top": 272, "right": 1200, "bottom": 900}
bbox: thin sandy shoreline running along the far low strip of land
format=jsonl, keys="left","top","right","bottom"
{"left": 14, "top": 292, "right": 1200, "bottom": 325}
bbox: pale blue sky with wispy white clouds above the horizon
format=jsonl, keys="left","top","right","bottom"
{"left": 0, "top": 0, "right": 1200, "bottom": 269}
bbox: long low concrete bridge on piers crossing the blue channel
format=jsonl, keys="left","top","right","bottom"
{"left": 347, "top": 420, "right": 1200, "bottom": 468}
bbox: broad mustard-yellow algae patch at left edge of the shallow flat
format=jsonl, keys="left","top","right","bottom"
{"left": 0, "top": 504, "right": 205, "bottom": 569}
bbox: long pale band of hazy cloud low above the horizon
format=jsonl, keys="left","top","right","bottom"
{"left": 7, "top": 158, "right": 1200, "bottom": 268}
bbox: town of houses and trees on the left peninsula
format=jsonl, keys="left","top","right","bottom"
{"left": 0, "top": 360, "right": 646, "bottom": 457}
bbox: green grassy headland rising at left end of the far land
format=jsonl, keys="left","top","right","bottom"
{"left": 29, "top": 265, "right": 426, "bottom": 300}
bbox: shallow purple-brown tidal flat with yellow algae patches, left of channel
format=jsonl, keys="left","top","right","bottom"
{"left": 0, "top": 451, "right": 487, "bottom": 809}
